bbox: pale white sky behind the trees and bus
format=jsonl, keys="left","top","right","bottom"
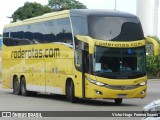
{"left": 0, "top": 0, "right": 136, "bottom": 34}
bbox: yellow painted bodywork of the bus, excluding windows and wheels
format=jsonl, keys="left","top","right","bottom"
{"left": 2, "top": 11, "right": 147, "bottom": 98}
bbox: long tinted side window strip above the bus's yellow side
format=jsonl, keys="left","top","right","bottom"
{"left": 3, "top": 18, "right": 73, "bottom": 46}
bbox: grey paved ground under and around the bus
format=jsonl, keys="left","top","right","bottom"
{"left": 0, "top": 80, "right": 160, "bottom": 120}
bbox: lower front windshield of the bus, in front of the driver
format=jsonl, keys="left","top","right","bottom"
{"left": 93, "top": 46, "right": 146, "bottom": 79}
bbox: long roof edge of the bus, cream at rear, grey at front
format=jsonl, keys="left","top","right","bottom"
{"left": 4, "top": 9, "right": 136, "bottom": 28}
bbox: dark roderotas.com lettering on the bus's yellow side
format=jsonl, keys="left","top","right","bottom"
{"left": 11, "top": 48, "right": 60, "bottom": 59}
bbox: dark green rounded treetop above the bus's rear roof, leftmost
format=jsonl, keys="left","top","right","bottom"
{"left": 12, "top": 2, "right": 52, "bottom": 22}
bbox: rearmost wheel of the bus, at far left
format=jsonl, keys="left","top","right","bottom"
{"left": 13, "top": 77, "right": 21, "bottom": 95}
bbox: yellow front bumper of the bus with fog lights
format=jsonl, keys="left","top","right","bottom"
{"left": 85, "top": 84, "right": 147, "bottom": 99}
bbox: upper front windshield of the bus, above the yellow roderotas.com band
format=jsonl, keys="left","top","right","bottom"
{"left": 88, "top": 16, "right": 144, "bottom": 41}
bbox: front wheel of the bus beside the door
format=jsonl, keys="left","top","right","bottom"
{"left": 67, "top": 81, "right": 76, "bottom": 103}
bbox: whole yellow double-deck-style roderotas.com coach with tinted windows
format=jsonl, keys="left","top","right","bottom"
{"left": 2, "top": 10, "right": 158, "bottom": 104}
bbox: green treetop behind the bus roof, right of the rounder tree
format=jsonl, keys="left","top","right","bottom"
{"left": 48, "top": 0, "right": 87, "bottom": 11}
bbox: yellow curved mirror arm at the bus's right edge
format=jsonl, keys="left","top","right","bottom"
{"left": 145, "top": 37, "right": 159, "bottom": 56}
